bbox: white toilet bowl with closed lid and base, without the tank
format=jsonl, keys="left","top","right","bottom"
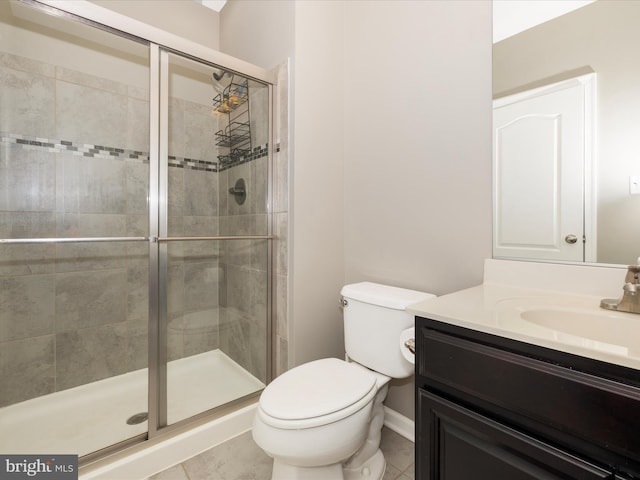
{"left": 253, "top": 358, "right": 390, "bottom": 480}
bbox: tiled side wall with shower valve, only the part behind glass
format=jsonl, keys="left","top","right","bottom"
{"left": 219, "top": 81, "right": 269, "bottom": 382}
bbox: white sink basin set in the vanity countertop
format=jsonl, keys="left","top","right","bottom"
{"left": 496, "top": 297, "right": 640, "bottom": 356}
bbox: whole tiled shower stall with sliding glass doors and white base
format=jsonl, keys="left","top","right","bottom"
{"left": 0, "top": 0, "right": 275, "bottom": 459}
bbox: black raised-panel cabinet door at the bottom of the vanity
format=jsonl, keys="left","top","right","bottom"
{"left": 416, "top": 389, "right": 613, "bottom": 480}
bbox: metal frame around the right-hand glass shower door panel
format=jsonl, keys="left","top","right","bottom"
{"left": 148, "top": 47, "right": 274, "bottom": 439}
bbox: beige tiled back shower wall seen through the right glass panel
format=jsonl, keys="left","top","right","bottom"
{"left": 167, "top": 94, "right": 219, "bottom": 360}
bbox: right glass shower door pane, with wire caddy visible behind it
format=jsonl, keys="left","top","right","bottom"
{"left": 158, "top": 52, "right": 270, "bottom": 425}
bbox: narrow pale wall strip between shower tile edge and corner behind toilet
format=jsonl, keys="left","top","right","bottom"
{"left": 290, "top": 0, "right": 345, "bottom": 365}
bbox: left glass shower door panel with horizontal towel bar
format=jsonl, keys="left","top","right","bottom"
{"left": 0, "top": 2, "right": 149, "bottom": 455}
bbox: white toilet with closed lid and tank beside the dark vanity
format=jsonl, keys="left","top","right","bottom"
{"left": 253, "top": 282, "right": 433, "bottom": 480}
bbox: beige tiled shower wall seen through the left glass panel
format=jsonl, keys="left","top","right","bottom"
{"left": 0, "top": 53, "right": 149, "bottom": 405}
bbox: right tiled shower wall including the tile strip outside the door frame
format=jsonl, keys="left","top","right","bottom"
{"left": 212, "top": 63, "right": 290, "bottom": 381}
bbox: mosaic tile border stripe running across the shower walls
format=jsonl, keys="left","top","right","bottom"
{"left": 0, "top": 132, "right": 272, "bottom": 172}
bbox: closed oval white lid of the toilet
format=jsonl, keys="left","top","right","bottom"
{"left": 260, "top": 358, "right": 376, "bottom": 420}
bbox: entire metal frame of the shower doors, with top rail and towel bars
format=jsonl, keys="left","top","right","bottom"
{"left": 6, "top": 0, "right": 277, "bottom": 465}
